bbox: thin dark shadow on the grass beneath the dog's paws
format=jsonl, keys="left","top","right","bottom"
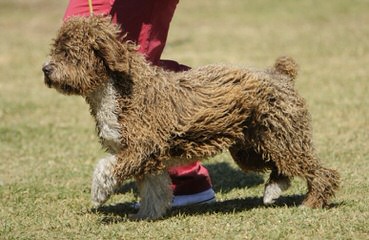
{"left": 91, "top": 195, "right": 304, "bottom": 224}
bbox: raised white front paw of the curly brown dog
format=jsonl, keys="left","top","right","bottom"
{"left": 91, "top": 156, "right": 118, "bottom": 207}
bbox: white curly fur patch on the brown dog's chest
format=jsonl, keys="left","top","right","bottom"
{"left": 91, "top": 83, "right": 121, "bottom": 152}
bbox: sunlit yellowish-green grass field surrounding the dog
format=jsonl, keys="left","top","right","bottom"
{"left": 0, "top": 0, "right": 369, "bottom": 239}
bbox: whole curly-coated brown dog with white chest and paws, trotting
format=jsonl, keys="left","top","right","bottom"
{"left": 43, "top": 16, "right": 339, "bottom": 219}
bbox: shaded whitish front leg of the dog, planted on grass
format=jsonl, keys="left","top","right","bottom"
{"left": 133, "top": 170, "right": 173, "bottom": 220}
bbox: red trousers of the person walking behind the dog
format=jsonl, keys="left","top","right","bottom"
{"left": 64, "top": 0, "right": 211, "bottom": 195}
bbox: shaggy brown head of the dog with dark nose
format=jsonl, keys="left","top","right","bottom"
{"left": 42, "top": 16, "right": 136, "bottom": 96}
